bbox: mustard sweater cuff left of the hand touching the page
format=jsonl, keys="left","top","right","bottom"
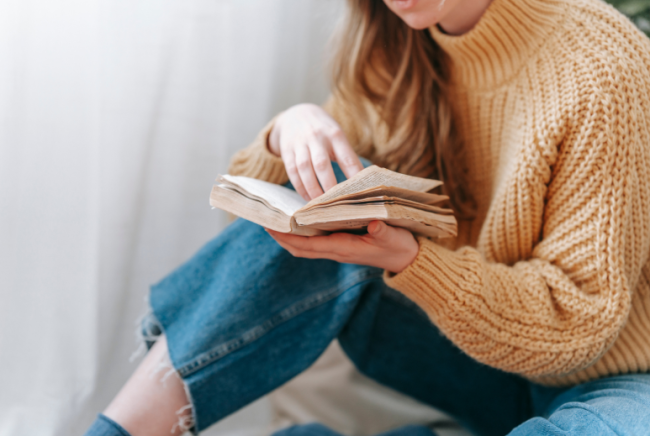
{"left": 228, "top": 117, "right": 289, "bottom": 185}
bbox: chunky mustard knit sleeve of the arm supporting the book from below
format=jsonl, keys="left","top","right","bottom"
{"left": 384, "top": 63, "right": 650, "bottom": 382}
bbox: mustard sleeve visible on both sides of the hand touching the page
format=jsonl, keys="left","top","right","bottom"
{"left": 228, "top": 97, "right": 365, "bottom": 184}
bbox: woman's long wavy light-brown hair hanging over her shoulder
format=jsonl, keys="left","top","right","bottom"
{"left": 332, "top": 0, "right": 476, "bottom": 219}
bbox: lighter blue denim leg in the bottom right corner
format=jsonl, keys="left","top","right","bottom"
{"left": 510, "top": 374, "right": 650, "bottom": 436}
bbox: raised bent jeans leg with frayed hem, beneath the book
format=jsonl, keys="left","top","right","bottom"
{"left": 150, "top": 220, "right": 383, "bottom": 430}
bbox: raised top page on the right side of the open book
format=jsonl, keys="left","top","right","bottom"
{"left": 307, "top": 165, "right": 442, "bottom": 207}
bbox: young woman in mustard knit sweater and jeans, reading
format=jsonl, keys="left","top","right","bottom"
{"left": 88, "top": 0, "right": 650, "bottom": 436}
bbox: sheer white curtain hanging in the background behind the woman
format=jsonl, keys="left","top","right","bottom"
{"left": 0, "top": 0, "right": 342, "bottom": 436}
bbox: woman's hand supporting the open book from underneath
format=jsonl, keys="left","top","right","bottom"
{"left": 266, "top": 221, "right": 420, "bottom": 273}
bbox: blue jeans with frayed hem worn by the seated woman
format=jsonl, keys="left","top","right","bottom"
{"left": 92, "top": 164, "right": 650, "bottom": 436}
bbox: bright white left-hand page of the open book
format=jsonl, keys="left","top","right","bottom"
{"left": 219, "top": 175, "right": 307, "bottom": 216}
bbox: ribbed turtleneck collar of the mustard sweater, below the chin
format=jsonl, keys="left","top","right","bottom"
{"left": 429, "top": 0, "right": 568, "bottom": 89}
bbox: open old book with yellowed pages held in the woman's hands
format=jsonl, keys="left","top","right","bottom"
{"left": 210, "top": 166, "right": 456, "bottom": 238}
